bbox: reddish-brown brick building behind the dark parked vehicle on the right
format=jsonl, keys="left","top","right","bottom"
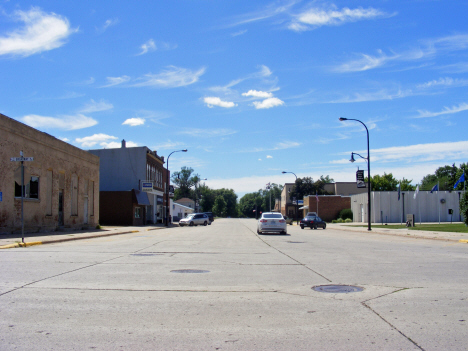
{"left": 302, "top": 195, "right": 351, "bottom": 222}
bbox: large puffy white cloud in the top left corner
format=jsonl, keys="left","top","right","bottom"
{"left": 0, "top": 7, "right": 77, "bottom": 56}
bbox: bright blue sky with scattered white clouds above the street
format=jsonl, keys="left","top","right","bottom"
{"left": 0, "top": 0, "right": 468, "bottom": 196}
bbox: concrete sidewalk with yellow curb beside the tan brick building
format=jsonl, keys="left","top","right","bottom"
{"left": 0, "top": 224, "right": 178, "bottom": 249}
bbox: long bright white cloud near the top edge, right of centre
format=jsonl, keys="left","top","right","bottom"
{"left": 289, "top": 6, "right": 388, "bottom": 31}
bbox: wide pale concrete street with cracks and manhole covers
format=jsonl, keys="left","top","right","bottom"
{"left": 0, "top": 219, "right": 468, "bottom": 350}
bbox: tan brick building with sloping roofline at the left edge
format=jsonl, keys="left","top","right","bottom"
{"left": 0, "top": 114, "right": 99, "bottom": 233}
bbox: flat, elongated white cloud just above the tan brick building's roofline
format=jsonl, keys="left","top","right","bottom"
{"left": 21, "top": 114, "right": 98, "bottom": 130}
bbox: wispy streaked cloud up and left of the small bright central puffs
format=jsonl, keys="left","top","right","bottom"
{"left": 133, "top": 66, "right": 205, "bottom": 88}
